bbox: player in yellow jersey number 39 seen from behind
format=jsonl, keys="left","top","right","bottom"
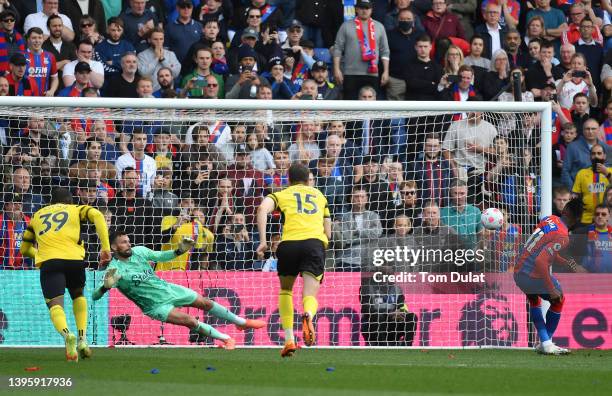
{"left": 20, "top": 188, "right": 111, "bottom": 361}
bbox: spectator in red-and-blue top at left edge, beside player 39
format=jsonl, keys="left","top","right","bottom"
{"left": 0, "top": 192, "right": 34, "bottom": 270}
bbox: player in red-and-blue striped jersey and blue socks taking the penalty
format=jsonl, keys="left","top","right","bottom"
{"left": 514, "top": 199, "right": 586, "bottom": 355}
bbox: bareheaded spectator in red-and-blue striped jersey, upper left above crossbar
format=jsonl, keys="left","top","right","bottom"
{"left": 25, "top": 27, "right": 59, "bottom": 96}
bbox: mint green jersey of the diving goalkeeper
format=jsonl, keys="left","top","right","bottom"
{"left": 108, "top": 246, "right": 176, "bottom": 312}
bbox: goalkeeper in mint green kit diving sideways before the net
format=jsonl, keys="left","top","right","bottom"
{"left": 93, "top": 232, "right": 265, "bottom": 350}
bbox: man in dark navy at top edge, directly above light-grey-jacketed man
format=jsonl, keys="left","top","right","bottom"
{"left": 120, "top": 0, "right": 158, "bottom": 51}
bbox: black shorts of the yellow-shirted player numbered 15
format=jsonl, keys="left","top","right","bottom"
{"left": 276, "top": 239, "right": 325, "bottom": 281}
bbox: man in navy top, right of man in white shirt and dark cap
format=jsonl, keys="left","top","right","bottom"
{"left": 95, "top": 17, "right": 136, "bottom": 78}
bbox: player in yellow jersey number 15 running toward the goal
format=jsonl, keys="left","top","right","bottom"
{"left": 257, "top": 163, "right": 331, "bottom": 357}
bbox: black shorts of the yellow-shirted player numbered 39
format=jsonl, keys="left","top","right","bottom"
{"left": 40, "top": 259, "right": 85, "bottom": 300}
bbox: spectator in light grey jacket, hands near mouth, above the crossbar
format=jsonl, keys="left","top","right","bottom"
{"left": 138, "top": 28, "right": 181, "bottom": 91}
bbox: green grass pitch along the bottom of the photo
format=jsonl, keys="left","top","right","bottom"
{"left": 0, "top": 348, "right": 612, "bottom": 396}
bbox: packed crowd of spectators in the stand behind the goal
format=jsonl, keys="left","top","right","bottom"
{"left": 0, "top": 0, "right": 612, "bottom": 271}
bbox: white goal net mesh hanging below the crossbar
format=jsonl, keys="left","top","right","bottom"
{"left": 0, "top": 104, "right": 550, "bottom": 347}
